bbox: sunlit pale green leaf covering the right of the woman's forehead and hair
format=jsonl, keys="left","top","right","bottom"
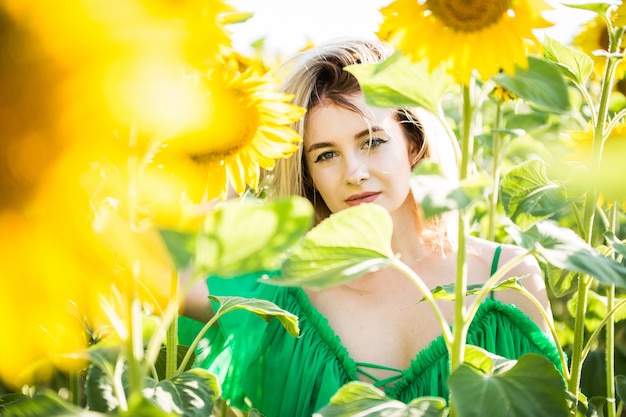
{"left": 345, "top": 53, "right": 452, "bottom": 114}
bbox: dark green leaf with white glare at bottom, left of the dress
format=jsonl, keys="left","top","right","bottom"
{"left": 144, "top": 368, "right": 220, "bottom": 417}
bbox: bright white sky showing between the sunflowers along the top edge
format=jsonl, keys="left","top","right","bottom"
{"left": 229, "top": 0, "right": 593, "bottom": 55}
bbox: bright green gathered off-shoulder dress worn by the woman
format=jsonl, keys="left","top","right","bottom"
{"left": 179, "top": 249, "right": 560, "bottom": 417}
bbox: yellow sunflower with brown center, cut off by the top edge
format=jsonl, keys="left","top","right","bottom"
{"left": 377, "top": 0, "right": 552, "bottom": 84}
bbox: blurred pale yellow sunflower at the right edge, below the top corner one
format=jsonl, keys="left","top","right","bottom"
{"left": 561, "top": 123, "right": 626, "bottom": 209}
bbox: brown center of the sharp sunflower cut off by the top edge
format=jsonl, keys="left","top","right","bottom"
{"left": 428, "top": 0, "right": 513, "bottom": 32}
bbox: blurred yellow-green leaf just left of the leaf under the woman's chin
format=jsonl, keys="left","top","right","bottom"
{"left": 195, "top": 197, "right": 313, "bottom": 277}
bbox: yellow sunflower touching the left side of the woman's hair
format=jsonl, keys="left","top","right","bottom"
{"left": 151, "top": 60, "right": 305, "bottom": 203}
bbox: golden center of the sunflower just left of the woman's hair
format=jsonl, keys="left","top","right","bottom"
{"left": 179, "top": 90, "right": 259, "bottom": 164}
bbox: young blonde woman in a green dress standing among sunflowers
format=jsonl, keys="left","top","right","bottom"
{"left": 178, "top": 40, "right": 558, "bottom": 417}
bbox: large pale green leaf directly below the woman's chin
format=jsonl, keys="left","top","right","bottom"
{"left": 266, "top": 204, "right": 395, "bottom": 289}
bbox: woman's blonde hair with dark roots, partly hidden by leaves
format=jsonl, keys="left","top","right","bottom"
{"left": 264, "top": 39, "right": 457, "bottom": 248}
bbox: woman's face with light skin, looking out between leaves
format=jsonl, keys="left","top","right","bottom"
{"left": 304, "top": 93, "right": 418, "bottom": 215}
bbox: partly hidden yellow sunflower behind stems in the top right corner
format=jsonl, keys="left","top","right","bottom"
{"left": 572, "top": 16, "right": 626, "bottom": 80}
